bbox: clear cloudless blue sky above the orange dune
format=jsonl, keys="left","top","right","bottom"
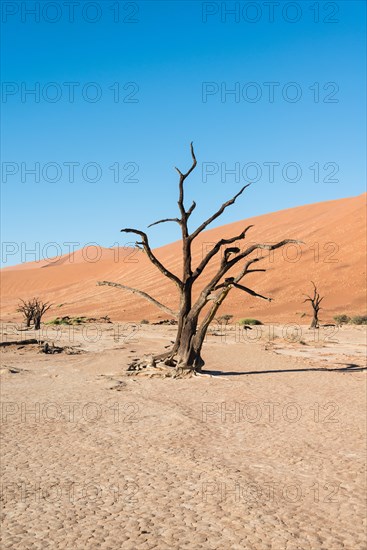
{"left": 1, "top": 0, "right": 366, "bottom": 265}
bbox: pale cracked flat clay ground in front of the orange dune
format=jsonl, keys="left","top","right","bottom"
{"left": 1, "top": 323, "right": 366, "bottom": 550}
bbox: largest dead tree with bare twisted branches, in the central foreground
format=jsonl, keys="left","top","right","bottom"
{"left": 97, "top": 143, "right": 300, "bottom": 376}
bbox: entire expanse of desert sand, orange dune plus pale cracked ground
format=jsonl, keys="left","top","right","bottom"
{"left": 0, "top": 195, "right": 367, "bottom": 550}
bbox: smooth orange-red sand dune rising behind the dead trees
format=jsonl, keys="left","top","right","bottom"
{"left": 1, "top": 194, "right": 366, "bottom": 323}
